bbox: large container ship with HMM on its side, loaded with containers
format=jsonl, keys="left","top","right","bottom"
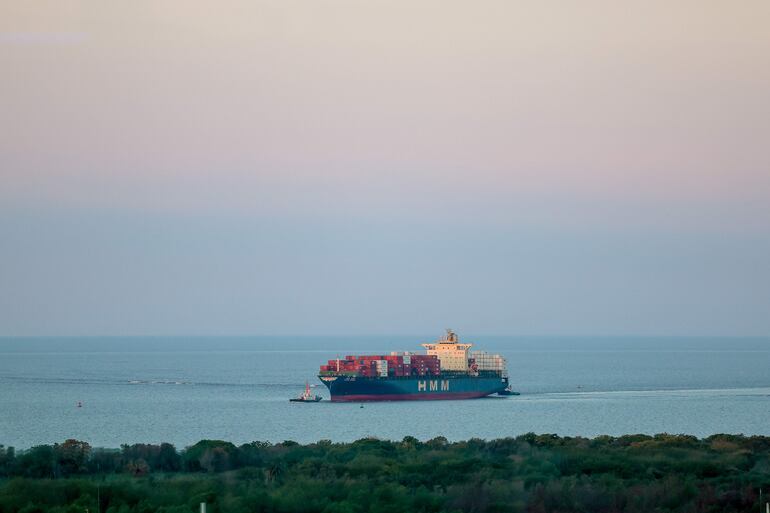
{"left": 318, "top": 330, "right": 510, "bottom": 402}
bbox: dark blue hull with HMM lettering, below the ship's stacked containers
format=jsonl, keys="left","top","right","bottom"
{"left": 319, "top": 375, "right": 508, "bottom": 402}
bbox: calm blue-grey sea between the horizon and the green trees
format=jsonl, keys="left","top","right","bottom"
{"left": 0, "top": 337, "right": 770, "bottom": 448}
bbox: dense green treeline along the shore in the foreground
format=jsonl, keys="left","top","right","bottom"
{"left": 0, "top": 433, "right": 770, "bottom": 513}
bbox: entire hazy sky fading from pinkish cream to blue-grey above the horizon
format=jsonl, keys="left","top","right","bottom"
{"left": 0, "top": 0, "right": 770, "bottom": 336}
